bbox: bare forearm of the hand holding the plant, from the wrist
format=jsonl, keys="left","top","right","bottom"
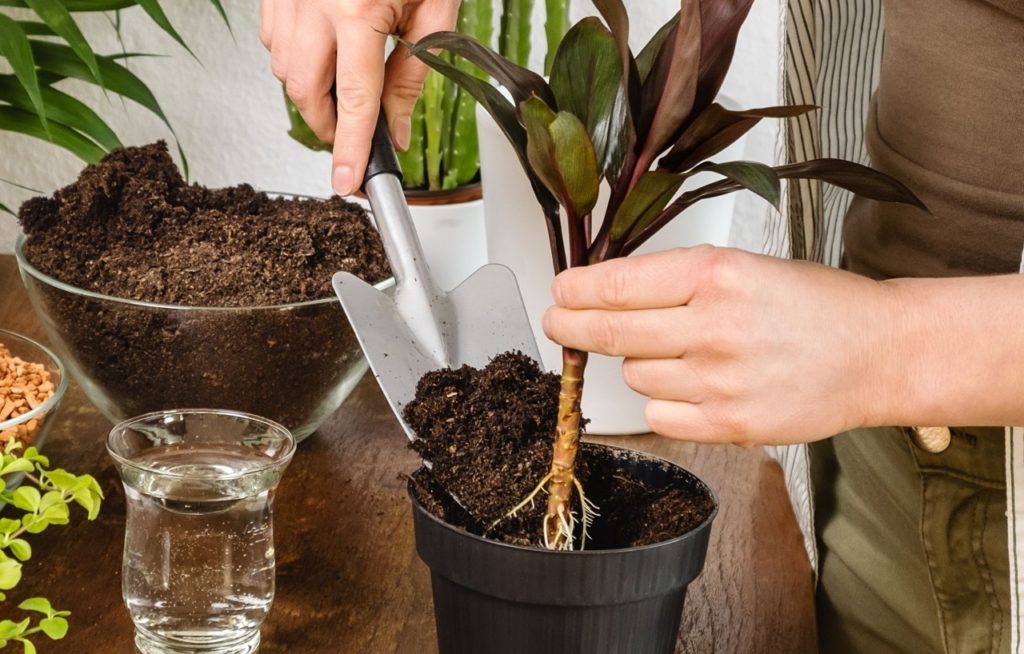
{"left": 867, "top": 275, "right": 1024, "bottom": 426}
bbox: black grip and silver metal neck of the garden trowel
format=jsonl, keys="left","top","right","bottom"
{"left": 364, "top": 107, "right": 438, "bottom": 299}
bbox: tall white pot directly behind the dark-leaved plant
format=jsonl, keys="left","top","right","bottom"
{"left": 476, "top": 103, "right": 743, "bottom": 434}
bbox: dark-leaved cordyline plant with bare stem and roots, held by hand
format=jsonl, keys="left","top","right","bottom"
{"left": 412, "top": 0, "right": 922, "bottom": 549}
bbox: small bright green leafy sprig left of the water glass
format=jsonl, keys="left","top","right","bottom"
{"left": 0, "top": 440, "right": 103, "bottom": 654}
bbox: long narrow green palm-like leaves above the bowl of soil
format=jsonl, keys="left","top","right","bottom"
{"left": 0, "top": 0, "right": 227, "bottom": 211}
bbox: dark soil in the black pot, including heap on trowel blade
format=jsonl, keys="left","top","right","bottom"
{"left": 404, "top": 352, "right": 714, "bottom": 550}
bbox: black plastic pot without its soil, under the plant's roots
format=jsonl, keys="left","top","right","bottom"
{"left": 410, "top": 445, "right": 718, "bottom": 654}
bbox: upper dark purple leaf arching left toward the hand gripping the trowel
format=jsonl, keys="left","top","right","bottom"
{"left": 407, "top": 32, "right": 557, "bottom": 107}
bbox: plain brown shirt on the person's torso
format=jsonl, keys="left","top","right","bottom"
{"left": 844, "top": 0, "right": 1024, "bottom": 278}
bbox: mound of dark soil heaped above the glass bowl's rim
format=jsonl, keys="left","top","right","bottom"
{"left": 18, "top": 141, "right": 390, "bottom": 306}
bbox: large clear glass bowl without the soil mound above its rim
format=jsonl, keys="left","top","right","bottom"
{"left": 14, "top": 234, "right": 394, "bottom": 441}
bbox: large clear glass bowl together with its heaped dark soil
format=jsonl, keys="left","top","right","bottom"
{"left": 15, "top": 142, "right": 393, "bottom": 440}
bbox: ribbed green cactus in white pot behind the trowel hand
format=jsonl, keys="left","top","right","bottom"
{"left": 286, "top": 0, "right": 569, "bottom": 191}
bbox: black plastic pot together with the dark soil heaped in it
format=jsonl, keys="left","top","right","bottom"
{"left": 403, "top": 352, "right": 718, "bottom": 654}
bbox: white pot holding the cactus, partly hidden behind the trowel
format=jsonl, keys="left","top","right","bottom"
{"left": 354, "top": 187, "right": 487, "bottom": 291}
